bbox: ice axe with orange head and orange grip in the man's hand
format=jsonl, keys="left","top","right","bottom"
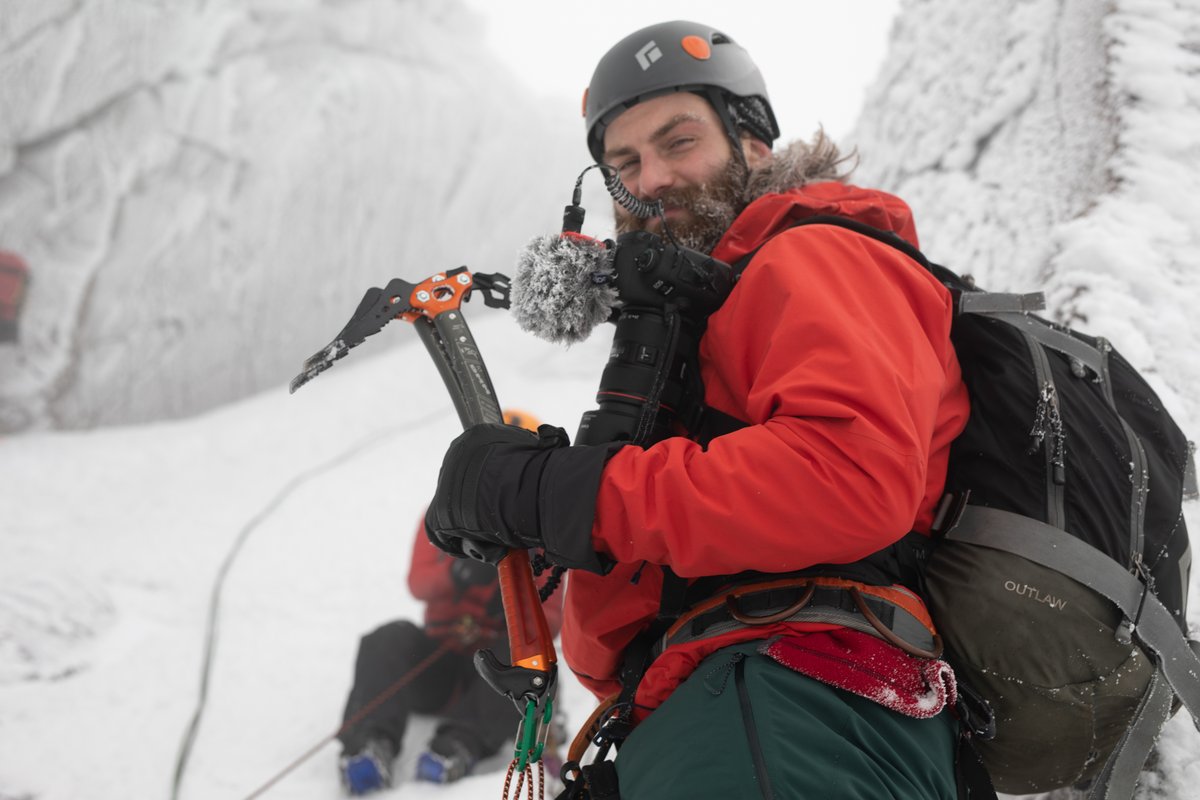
{"left": 290, "top": 266, "right": 558, "bottom": 799}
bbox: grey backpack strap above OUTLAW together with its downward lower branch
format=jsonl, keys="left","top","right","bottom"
{"left": 946, "top": 505, "right": 1200, "bottom": 800}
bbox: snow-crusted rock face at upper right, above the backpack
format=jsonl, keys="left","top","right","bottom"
{"left": 853, "top": 0, "right": 1200, "bottom": 435}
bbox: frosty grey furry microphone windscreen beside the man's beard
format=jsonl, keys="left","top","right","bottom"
{"left": 511, "top": 234, "right": 617, "bottom": 344}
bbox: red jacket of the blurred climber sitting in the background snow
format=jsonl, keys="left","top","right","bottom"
{"left": 408, "top": 524, "right": 563, "bottom": 652}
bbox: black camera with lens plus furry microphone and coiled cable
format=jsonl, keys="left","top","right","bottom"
{"left": 510, "top": 164, "right": 733, "bottom": 445}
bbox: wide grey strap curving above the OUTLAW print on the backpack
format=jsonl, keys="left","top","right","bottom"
{"left": 946, "top": 505, "right": 1200, "bottom": 728}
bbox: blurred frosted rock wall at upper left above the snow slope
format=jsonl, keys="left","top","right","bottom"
{"left": 0, "top": 0, "right": 587, "bottom": 432}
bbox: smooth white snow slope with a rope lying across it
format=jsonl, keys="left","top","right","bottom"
{"left": 0, "top": 311, "right": 608, "bottom": 800}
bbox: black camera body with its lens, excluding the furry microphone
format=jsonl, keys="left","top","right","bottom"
{"left": 575, "top": 230, "right": 733, "bottom": 445}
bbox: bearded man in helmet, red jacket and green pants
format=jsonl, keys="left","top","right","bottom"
{"left": 426, "top": 22, "right": 968, "bottom": 800}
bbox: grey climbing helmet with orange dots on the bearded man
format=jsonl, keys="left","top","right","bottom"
{"left": 583, "top": 20, "right": 779, "bottom": 161}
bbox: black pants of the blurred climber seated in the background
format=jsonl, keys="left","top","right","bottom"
{"left": 337, "top": 621, "right": 520, "bottom": 759}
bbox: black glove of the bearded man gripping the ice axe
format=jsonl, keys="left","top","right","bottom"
{"left": 425, "top": 425, "right": 622, "bottom": 572}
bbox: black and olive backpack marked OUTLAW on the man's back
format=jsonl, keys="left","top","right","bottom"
{"left": 739, "top": 216, "right": 1200, "bottom": 798}
